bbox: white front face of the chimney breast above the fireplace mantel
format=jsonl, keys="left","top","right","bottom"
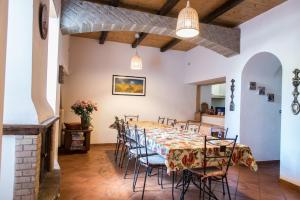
{"left": 4, "top": 0, "right": 38, "bottom": 124}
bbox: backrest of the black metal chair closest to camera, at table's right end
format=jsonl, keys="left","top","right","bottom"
{"left": 203, "top": 136, "right": 238, "bottom": 174}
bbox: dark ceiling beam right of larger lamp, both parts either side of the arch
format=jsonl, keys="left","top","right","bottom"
{"left": 160, "top": 0, "right": 244, "bottom": 52}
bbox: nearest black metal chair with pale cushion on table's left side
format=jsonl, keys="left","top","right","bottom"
{"left": 133, "top": 129, "right": 166, "bottom": 200}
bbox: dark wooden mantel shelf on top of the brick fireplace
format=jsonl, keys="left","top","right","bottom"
{"left": 3, "top": 116, "right": 59, "bottom": 135}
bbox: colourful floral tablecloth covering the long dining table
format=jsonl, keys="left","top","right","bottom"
{"left": 130, "top": 122, "right": 258, "bottom": 172}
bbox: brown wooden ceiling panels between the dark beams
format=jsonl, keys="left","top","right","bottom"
{"left": 72, "top": 0, "right": 286, "bottom": 51}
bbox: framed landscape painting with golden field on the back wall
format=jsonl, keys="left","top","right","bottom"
{"left": 112, "top": 75, "right": 146, "bottom": 96}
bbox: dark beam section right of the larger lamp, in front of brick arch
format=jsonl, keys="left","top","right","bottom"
{"left": 201, "top": 0, "right": 244, "bottom": 23}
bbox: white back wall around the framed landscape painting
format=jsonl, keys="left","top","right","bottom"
{"left": 63, "top": 37, "right": 196, "bottom": 143}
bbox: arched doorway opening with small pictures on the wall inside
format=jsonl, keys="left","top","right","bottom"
{"left": 240, "top": 52, "right": 282, "bottom": 161}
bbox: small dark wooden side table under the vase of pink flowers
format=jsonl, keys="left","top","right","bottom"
{"left": 63, "top": 128, "right": 93, "bottom": 153}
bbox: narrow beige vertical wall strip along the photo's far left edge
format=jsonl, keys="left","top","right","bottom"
{"left": 0, "top": 0, "right": 8, "bottom": 179}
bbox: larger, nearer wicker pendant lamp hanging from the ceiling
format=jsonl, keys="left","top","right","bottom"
{"left": 176, "top": 1, "right": 199, "bottom": 38}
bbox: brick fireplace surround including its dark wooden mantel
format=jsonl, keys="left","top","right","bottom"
{"left": 3, "top": 117, "right": 60, "bottom": 200}
